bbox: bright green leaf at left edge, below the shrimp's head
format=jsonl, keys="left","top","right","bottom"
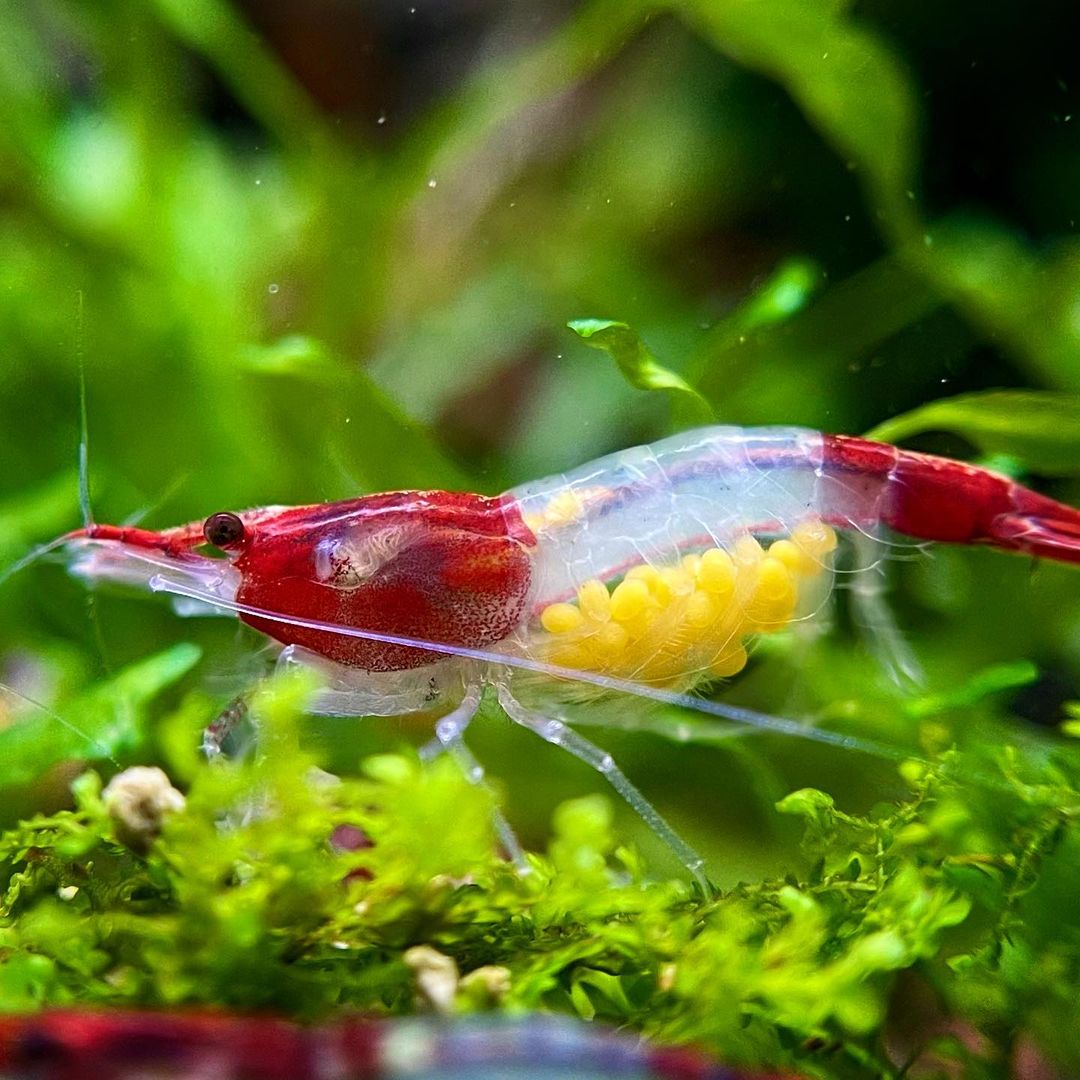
{"left": 0, "top": 643, "right": 201, "bottom": 785}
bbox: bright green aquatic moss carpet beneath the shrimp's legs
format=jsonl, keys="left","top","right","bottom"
{"left": 0, "top": 680, "right": 1080, "bottom": 1076}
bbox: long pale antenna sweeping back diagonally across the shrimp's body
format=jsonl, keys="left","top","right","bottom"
{"left": 147, "top": 573, "right": 912, "bottom": 761}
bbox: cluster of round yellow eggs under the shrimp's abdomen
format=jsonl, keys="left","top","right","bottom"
{"left": 539, "top": 519, "right": 836, "bottom": 686}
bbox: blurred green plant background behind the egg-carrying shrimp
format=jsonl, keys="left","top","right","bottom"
{"left": 0, "top": 0, "right": 1080, "bottom": 883}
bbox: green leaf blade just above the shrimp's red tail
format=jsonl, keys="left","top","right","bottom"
{"left": 868, "top": 390, "right": 1080, "bottom": 476}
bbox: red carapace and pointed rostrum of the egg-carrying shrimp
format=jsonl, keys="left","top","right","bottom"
{"left": 70, "top": 491, "right": 536, "bottom": 672}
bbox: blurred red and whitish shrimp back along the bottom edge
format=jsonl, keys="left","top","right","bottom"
{"left": 0, "top": 1010, "right": 794, "bottom": 1080}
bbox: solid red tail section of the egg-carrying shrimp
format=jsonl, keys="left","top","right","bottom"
{"left": 824, "top": 435, "right": 1080, "bottom": 563}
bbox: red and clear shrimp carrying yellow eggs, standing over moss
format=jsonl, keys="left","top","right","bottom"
{"left": 57, "top": 427, "right": 1080, "bottom": 879}
